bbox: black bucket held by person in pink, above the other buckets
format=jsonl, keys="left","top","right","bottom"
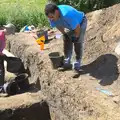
{"left": 6, "top": 57, "right": 25, "bottom": 73}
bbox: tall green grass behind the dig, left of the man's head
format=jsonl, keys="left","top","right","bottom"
{"left": 0, "top": 0, "right": 49, "bottom": 31}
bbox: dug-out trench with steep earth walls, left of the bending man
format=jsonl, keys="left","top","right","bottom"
{"left": 0, "top": 34, "right": 51, "bottom": 120}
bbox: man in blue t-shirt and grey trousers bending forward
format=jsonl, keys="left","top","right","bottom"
{"left": 45, "top": 3, "right": 87, "bottom": 71}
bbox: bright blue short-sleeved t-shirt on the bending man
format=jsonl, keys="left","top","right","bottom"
{"left": 50, "top": 5, "right": 84, "bottom": 30}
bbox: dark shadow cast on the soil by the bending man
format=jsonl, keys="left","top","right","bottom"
{"left": 73, "top": 54, "right": 119, "bottom": 86}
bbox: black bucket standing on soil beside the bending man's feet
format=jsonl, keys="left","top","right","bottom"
{"left": 49, "top": 52, "right": 63, "bottom": 69}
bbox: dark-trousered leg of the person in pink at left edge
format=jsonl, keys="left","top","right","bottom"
{"left": 0, "top": 59, "right": 5, "bottom": 86}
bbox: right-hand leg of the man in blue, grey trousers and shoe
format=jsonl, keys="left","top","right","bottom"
{"left": 74, "top": 15, "right": 87, "bottom": 71}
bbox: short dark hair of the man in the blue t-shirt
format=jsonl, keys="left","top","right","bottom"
{"left": 45, "top": 3, "right": 58, "bottom": 16}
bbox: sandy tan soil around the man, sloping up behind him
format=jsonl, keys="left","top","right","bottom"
{"left": 0, "top": 4, "right": 120, "bottom": 120}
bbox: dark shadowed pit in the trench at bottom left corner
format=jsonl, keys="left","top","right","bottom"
{"left": 0, "top": 101, "right": 51, "bottom": 120}
